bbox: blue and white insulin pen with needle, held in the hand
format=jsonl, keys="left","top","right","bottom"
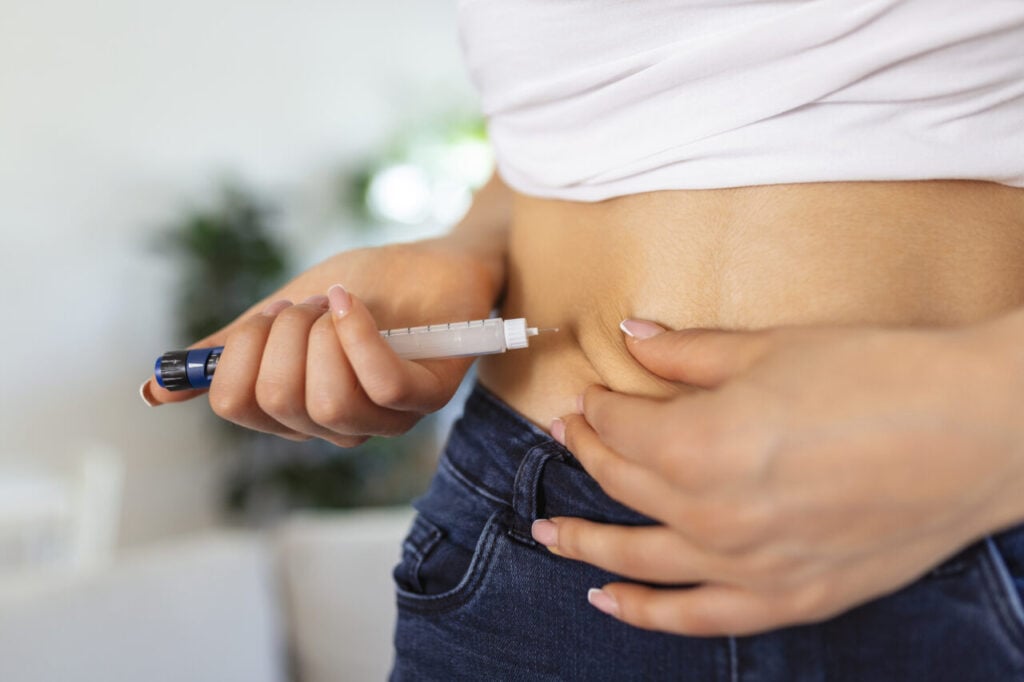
{"left": 155, "top": 317, "right": 558, "bottom": 391}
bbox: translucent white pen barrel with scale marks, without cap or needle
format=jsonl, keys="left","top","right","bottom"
{"left": 381, "top": 318, "right": 507, "bottom": 359}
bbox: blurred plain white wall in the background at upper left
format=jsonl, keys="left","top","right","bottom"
{"left": 0, "top": 0, "right": 474, "bottom": 544}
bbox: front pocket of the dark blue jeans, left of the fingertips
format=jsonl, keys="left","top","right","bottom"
{"left": 392, "top": 503, "right": 504, "bottom": 610}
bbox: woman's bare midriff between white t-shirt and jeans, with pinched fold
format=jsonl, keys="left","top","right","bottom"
{"left": 479, "top": 181, "right": 1024, "bottom": 427}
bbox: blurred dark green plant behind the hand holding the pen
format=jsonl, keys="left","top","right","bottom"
{"left": 160, "top": 184, "right": 435, "bottom": 523}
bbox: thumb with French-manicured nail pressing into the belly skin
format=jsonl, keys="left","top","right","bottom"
{"left": 618, "top": 319, "right": 770, "bottom": 388}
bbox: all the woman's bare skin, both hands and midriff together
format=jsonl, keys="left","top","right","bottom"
{"left": 143, "top": 176, "right": 1024, "bottom": 635}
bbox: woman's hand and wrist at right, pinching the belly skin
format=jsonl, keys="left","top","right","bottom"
{"left": 535, "top": 310, "right": 1024, "bottom": 636}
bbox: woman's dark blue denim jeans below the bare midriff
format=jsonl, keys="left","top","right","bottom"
{"left": 391, "top": 386, "right": 1024, "bottom": 682}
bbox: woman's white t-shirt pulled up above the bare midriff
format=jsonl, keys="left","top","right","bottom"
{"left": 460, "top": 0, "right": 1024, "bottom": 201}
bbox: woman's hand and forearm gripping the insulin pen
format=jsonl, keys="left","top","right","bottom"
{"left": 142, "top": 174, "right": 511, "bottom": 445}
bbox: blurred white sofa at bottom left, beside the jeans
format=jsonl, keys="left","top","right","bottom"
{"left": 0, "top": 509, "right": 412, "bottom": 682}
